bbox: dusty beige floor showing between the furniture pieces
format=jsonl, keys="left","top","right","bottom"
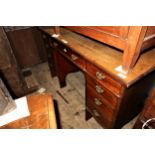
{"left": 31, "top": 63, "right": 136, "bottom": 129}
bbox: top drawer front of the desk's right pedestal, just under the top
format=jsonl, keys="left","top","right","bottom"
{"left": 87, "top": 63, "right": 122, "bottom": 95}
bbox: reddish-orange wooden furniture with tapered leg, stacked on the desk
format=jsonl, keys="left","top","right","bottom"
{"left": 61, "top": 26, "right": 155, "bottom": 71}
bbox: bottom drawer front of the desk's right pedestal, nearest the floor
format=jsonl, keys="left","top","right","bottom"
{"left": 86, "top": 99, "right": 114, "bottom": 128}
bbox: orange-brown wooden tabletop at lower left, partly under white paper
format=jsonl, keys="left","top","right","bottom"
{"left": 0, "top": 94, "right": 57, "bottom": 129}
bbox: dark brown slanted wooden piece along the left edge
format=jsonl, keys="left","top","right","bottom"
{"left": 0, "top": 27, "right": 27, "bottom": 96}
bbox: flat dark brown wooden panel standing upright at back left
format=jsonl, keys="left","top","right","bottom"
{"left": 6, "top": 27, "right": 47, "bottom": 69}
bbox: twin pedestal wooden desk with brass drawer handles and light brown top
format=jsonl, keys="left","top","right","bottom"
{"left": 39, "top": 27, "right": 155, "bottom": 128}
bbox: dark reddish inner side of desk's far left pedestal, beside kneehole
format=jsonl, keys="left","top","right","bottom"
{"left": 55, "top": 51, "right": 78, "bottom": 87}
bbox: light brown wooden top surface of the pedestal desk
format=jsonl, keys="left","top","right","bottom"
{"left": 40, "top": 27, "right": 155, "bottom": 87}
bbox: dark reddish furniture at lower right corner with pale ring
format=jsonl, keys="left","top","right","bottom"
{"left": 133, "top": 88, "right": 155, "bottom": 129}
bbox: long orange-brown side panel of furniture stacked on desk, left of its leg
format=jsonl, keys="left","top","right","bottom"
{"left": 65, "top": 26, "right": 128, "bottom": 49}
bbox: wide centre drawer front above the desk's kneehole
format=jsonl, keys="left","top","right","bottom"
{"left": 59, "top": 46, "right": 86, "bottom": 70}
